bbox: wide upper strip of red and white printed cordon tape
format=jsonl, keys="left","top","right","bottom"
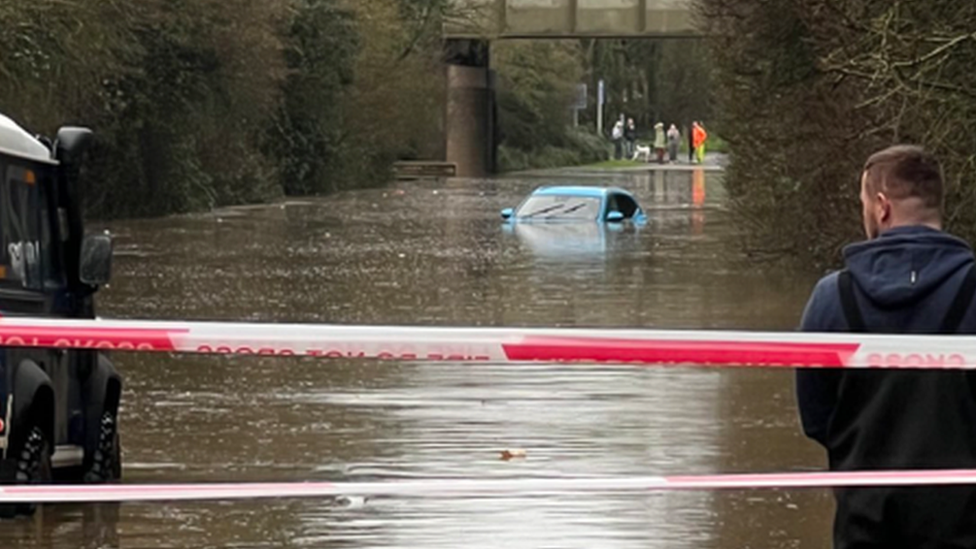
{"left": 0, "top": 317, "right": 976, "bottom": 369}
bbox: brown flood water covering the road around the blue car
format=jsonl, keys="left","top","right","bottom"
{"left": 0, "top": 172, "right": 832, "bottom": 549}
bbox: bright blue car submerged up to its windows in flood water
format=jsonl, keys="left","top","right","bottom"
{"left": 502, "top": 186, "right": 647, "bottom": 223}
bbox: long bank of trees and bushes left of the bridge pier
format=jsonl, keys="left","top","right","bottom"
{"left": 0, "top": 0, "right": 450, "bottom": 217}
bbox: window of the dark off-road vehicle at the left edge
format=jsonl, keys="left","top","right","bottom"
{"left": 0, "top": 156, "right": 51, "bottom": 290}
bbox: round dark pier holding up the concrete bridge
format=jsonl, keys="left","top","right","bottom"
{"left": 444, "top": 39, "right": 497, "bottom": 177}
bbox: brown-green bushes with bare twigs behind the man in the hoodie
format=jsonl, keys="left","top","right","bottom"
{"left": 699, "top": 0, "right": 976, "bottom": 263}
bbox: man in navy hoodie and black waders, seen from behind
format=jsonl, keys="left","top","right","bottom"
{"left": 796, "top": 146, "right": 976, "bottom": 549}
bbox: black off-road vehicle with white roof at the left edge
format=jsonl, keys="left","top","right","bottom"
{"left": 0, "top": 115, "right": 122, "bottom": 516}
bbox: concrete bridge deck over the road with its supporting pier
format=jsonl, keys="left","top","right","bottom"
{"left": 444, "top": 0, "right": 697, "bottom": 177}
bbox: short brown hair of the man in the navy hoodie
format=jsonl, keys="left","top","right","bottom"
{"left": 864, "top": 145, "right": 945, "bottom": 212}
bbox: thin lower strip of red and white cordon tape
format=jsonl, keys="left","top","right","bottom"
{"left": 0, "top": 469, "right": 976, "bottom": 503}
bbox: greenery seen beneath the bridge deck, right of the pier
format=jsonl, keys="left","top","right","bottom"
{"left": 492, "top": 39, "right": 717, "bottom": 171}
